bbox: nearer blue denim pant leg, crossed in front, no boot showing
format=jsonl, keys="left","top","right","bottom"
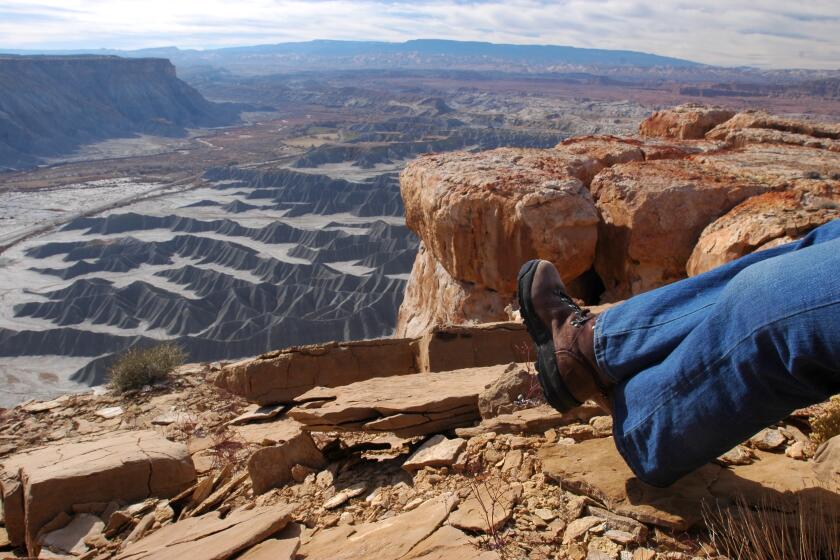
{"left": 607, "top": 235, "right": 840, "bottom": 486}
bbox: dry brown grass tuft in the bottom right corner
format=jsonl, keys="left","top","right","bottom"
{"left": 703, "top": 489, "right": 840, "bottom": 560}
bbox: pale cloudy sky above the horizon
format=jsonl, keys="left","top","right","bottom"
{"left": 0, "top": 0, "right": 840, "bottom": 69}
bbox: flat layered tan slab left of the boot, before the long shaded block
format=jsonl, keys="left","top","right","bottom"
{"left": 289, "top": 365, "right": 507, "bottom": 437}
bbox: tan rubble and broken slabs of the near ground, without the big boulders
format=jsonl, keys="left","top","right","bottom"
{"left": 0, "top": 331, "right": 840, "bottom": 560}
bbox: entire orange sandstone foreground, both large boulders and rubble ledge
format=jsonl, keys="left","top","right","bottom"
{"left": 0, "top": 106, "right": 840, "bottom": 560}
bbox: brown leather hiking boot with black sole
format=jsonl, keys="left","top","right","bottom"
{"left": 518, "top": 260, "right": 612, "bottom": 412}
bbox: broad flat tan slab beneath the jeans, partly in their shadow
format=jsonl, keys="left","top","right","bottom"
{"left": 539, "top": 438, "right": 840, "bottom": 531}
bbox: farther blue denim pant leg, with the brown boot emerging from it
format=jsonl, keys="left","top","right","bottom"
{"left": 594, "top": 220, "right": 840, "bottom": 382}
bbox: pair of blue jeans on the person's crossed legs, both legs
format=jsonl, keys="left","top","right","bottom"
{"left": 595, "top": 220, "right": 840, "bottom": 486}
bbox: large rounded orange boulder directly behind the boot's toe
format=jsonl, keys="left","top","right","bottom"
{"left": 400, "top": 148, "right": 598, "bottom": 296}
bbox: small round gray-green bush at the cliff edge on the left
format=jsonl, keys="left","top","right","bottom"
{"left": 108, "top": 342, "right": 187, "bottom": 393}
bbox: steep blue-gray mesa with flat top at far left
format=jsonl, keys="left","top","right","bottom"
{"left": 0, "top": 55, "right": 239, "bottom": 170}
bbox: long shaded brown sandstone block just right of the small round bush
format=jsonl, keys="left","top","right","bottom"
{"left": 215, "top": 338, "right": 416, "bottom": 405}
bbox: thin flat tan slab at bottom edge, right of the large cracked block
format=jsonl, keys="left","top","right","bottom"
{"left": 117, "top": 505, "right": 295, "bottom": 560}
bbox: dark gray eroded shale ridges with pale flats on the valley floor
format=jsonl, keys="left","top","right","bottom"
{"left": 0, "top": 168, "right": 417, "bottom": 385}
